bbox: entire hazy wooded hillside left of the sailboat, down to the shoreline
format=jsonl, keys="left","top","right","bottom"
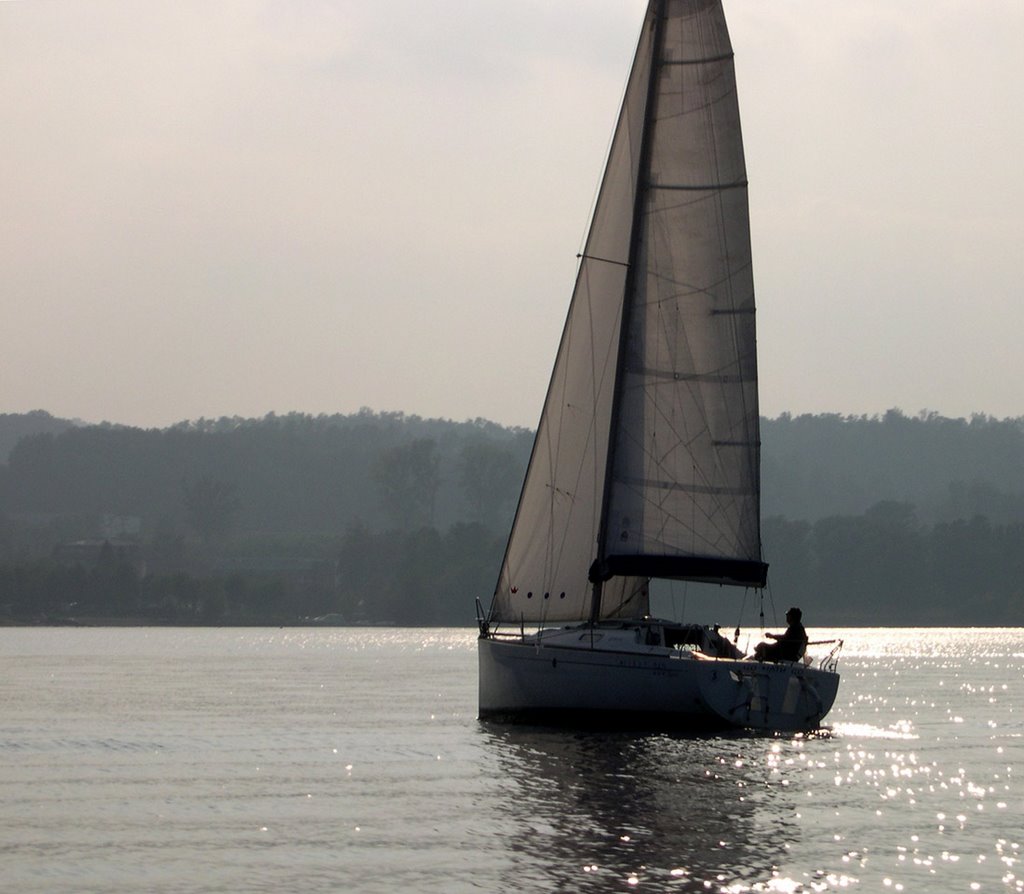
{"left": 0, "top": 411, "right": 532, "bottom": 624}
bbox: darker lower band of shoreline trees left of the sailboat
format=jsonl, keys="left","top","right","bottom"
{"left": 0, "top": 523, "right": 504, "bottom": 627}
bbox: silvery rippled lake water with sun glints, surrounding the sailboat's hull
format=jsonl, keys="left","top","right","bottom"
{"left": 0, "top": 628, "right": 1024, "bottom": 892}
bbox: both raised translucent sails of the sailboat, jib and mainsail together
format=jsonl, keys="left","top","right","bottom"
{"left": 490, "top": 0, "right": 766, "bottom": 623}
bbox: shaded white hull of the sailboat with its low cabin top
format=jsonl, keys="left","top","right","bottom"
{"left": 479, "top": 626, "right": 839, "bottom": 731}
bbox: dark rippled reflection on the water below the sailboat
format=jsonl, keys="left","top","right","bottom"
{"left": 484, "top": 724, "right": 799, "bottom": 891}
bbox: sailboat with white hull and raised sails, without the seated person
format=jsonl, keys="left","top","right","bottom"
{"left": 477, "top": 0, "right": 839, "bottom": 730}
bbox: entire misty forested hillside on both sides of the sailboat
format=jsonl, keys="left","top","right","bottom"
{"left": 0, "top": 411, "right": 1024, "bottom": 624}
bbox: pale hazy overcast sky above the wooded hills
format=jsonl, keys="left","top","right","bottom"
{"left": 0, "top": 0, "right": 1024, "bottom": 426}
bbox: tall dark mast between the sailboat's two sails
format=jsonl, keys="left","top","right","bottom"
{"left": 590, "top": 0, "right": 666, "bottom": 624}
